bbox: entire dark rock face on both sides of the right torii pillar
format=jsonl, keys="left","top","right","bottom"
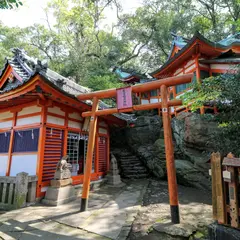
{"left": 110, "top": 113, "right": 217, "bottom": 189}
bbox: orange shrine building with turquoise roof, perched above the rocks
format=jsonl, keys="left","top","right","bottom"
{"left": 115, "top": 32, "right": 240, "bottom": 115}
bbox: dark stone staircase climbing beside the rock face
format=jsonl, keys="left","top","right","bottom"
{"left": 113, "top": 149, "right": 148, "bottom": 179}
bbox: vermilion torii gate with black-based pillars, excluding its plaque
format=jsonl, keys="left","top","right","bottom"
{"left": 77, "top": 74, "right": 193, "bottom": 224}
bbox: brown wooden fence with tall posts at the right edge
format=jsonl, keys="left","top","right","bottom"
{"left": 211, "top": 153, "right": 240, "bottom": 228}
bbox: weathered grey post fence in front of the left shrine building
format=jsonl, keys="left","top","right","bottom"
{"left": 0, "top": 172, "right": 37, "bottom": 210}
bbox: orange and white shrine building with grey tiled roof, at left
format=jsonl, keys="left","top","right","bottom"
{"left": 0, "top": 49, "right": 126, "bottom": 198}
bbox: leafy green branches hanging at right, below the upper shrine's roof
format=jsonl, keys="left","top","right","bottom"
{"left": 183, "top": 67, "right": 240, "bottom": 155}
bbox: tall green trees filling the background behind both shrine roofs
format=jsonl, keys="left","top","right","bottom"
{"left": 0, "top": 0, "right": 240, "bottom": 89}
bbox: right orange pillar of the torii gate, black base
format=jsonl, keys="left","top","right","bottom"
{"left": 161, "top": 85, "right": 180, "bottom": 224}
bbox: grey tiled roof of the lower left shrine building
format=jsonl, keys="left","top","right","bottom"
{"left": 0, "top": 48, "right": 133, "bottom": 124}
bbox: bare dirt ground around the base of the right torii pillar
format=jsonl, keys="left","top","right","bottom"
{"left": 128, "top": 180, "right": 212, "bottom": 240}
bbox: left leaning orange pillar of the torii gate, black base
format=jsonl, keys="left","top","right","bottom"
{"left": 80, "top": 97, "right": 98, "bottom": 212}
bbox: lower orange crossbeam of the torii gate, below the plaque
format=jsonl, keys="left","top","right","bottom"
{"left": 82, "top": 100, "right": 182, "bottom": 117}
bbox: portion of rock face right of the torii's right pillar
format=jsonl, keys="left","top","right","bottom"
{"left": 172, "top": 113, "right": 218, "bottom": 188}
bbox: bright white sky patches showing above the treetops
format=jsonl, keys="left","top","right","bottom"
{"left": 0, "top": 0, "right": 142, "bottom": 28}
